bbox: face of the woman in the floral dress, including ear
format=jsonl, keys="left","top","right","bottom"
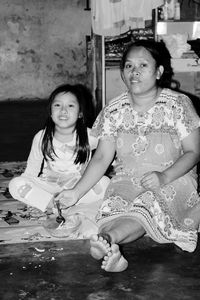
{"left": 123, "top": 47, "right": 163, "bottom": 95}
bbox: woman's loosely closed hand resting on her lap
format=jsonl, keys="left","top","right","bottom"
{"left": 141, "top": 171, "right": 165, "bottom": 191}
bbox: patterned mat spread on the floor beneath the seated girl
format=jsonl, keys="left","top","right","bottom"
{"left": 0, "top": 162, "right": 96, "bottom": 244}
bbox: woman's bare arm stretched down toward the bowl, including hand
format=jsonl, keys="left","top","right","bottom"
{"left": 55, "top": 139, "right": 115, "bottom": 207}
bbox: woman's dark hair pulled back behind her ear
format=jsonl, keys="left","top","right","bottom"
{"left": 120, "top": 40, "right": 173, "bottom": 87}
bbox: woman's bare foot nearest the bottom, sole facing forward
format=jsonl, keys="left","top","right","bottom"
{"left": 101, "top": 244, "right": 128, "bottom": 272}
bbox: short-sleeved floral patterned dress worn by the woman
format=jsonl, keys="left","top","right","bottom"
{"left": 93, "top": 89, "right": 200, "bottom": 252}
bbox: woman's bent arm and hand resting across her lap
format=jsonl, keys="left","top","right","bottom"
{"left": 141, "top": 128, "right": 200, "bottom": 189}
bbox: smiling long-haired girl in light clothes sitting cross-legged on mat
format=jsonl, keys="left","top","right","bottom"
{"left": 9, "top": 84, "right": 109, "bottom": 227}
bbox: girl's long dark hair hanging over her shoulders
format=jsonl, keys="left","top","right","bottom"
{"left": 42, "top": 84, "right": 94, "bottom": 164}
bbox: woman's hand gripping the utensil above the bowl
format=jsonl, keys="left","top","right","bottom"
{"left": 54, "top": 189, "right": 79, "bottom": 208}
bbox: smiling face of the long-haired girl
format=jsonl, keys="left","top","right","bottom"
{"left": 51, "top": 92, "right": 80, "bottom": 131}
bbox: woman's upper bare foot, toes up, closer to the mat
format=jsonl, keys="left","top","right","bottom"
{"left": 90, "top": 234, "right": 111, "bottom": 260}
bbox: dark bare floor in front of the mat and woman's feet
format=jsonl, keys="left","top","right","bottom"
{"left": 0, "top": 237, "right": 200, "bottom": 300}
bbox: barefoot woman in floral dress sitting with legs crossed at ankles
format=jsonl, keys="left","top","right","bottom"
{"left": 57, "top": 40, "right": 200, "bottom": 272}
